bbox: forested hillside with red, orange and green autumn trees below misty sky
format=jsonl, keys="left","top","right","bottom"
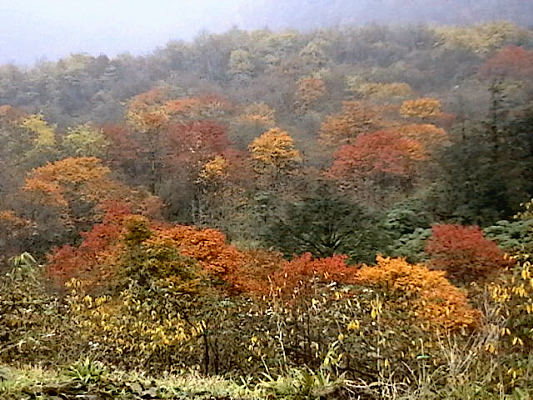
{"left": 0, "top": 20, "right": 533, "bottom": 399}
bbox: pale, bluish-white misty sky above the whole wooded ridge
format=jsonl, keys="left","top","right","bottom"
{"left": 0, "top": 0, "right": 533, "bottom": 64}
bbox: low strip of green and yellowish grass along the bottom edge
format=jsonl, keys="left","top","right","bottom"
{"left": 0, "top": 359, "right": 533, "bottom": 400}
